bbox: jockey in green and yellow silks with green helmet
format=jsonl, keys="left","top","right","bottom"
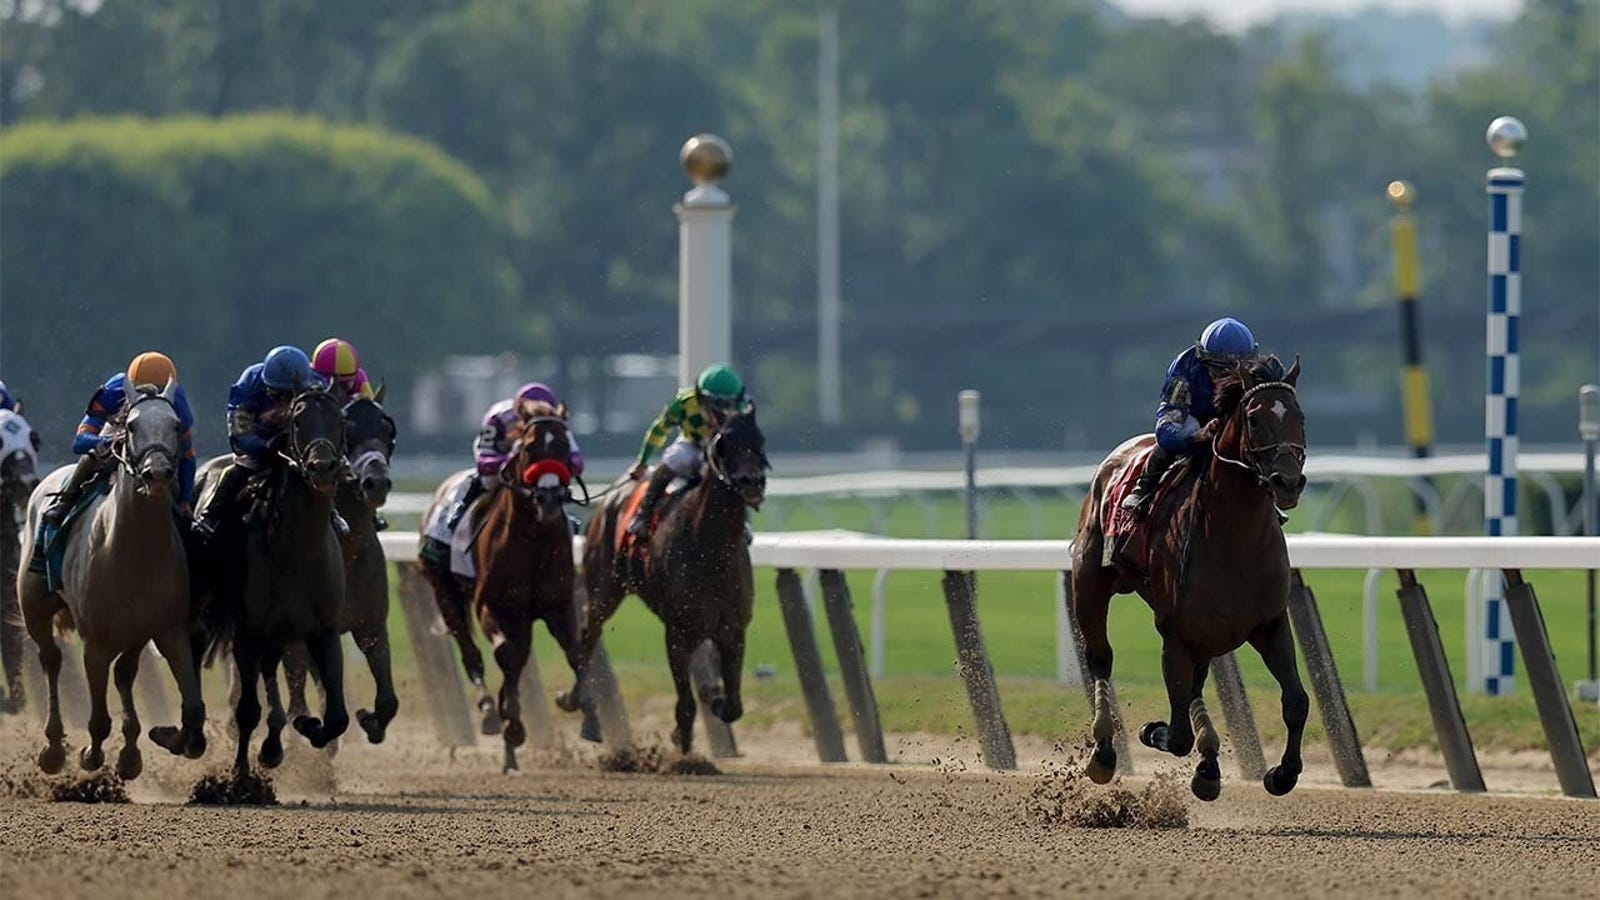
{"left": 627, "top": 362, "right": 750, "bottom": 536}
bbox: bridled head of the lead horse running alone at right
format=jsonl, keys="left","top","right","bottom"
{"left": 1213, "top": 356, "right": 1306, "bottom": 509}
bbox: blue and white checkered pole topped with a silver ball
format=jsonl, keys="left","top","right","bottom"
{"left": 1480, "top": 115, "right": 1528, "bottom": 695}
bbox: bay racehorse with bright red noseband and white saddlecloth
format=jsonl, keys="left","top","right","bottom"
{"left": 422, "top": 402, "right": 600, "bottom": 772}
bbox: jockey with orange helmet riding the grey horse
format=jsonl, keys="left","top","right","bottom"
{"left": 38, "top": 351, "right": 195, "bottom": 531}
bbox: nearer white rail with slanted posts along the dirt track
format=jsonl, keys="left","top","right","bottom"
{"left": 384, "top": 532, "right": 1600, "bottom": 798}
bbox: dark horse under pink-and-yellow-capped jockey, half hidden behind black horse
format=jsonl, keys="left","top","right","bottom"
{"left": 283, "top": 388, "right": 400, "bottom": 743}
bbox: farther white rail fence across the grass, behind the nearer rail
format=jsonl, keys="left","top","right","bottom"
{"left": 386, "top": 453, "right": 1584, "bottom": 538}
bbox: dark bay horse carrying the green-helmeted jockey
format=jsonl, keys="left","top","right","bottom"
{"left": 582, "top": 407, "right": 771, "bottom": 753}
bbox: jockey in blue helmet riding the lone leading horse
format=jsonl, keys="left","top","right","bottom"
{"left": 1122, "top": 317, "right": 1256, "bottom": 517}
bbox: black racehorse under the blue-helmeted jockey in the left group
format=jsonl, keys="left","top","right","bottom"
{"left": 197, "top": 389, "right": 350, "bottom": 775}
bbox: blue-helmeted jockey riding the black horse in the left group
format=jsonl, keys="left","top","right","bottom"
{"left": 194, "top": 346, "right": 326, "bottom": 543}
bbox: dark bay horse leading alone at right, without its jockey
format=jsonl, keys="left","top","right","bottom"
{"left": 1072, "top": 357, "right": 1309, "bottom": 801}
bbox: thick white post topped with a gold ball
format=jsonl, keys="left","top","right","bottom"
{"left": 672, "top": 135, "right": 734, "bottom": 386}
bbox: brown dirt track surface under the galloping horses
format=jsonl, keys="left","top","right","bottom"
{"left": 0, "top": 719, "right": 1600, "bottom": 900}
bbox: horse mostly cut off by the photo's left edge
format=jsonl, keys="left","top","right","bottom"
{"left": 0, "top": 410, "right": 38, "bottom": 713}
